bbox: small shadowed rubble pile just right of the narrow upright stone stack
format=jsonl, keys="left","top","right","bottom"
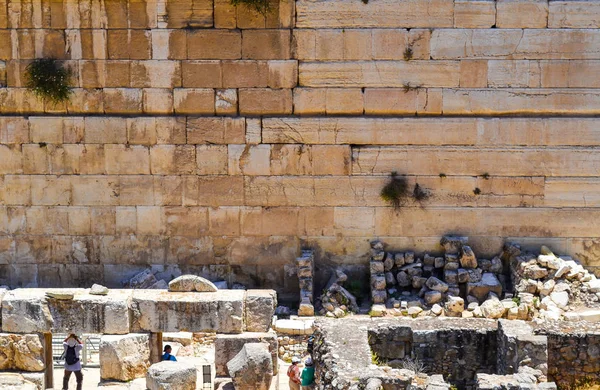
{"left": 318, "top": 269, "right": 358, "bottom": 318}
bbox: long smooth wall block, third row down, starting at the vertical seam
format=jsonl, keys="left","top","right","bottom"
{"left": 299, "top": 61, "right": 460, "bottom": 88}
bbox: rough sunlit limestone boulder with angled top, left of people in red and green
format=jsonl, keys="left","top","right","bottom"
{"left": 227, "top": 343, "right": 273, "bottom": 390}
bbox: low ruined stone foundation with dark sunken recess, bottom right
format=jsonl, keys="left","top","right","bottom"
{"left": 314, "top": 317, "right": 600, "bottom": 390}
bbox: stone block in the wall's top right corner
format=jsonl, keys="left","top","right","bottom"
{"left": 548, "top": 0, "right": 600, "bottom": 28}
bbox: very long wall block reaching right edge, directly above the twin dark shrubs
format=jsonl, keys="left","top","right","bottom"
{"left": 352, "top": 147, "right": 596, "bottom": 176}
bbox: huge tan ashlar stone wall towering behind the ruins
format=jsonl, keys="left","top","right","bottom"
{"left": 0, "top": 0, "right": 600, "bottom": 291}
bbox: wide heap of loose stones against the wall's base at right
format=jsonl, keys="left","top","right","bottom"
{"left": 370, "top": 236, "right": 600, "bottom": 320}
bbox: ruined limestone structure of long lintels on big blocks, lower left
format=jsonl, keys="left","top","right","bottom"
{"left": 0, "top": 289, "right": 278, "bottom": 390}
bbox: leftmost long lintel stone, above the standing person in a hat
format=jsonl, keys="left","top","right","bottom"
{"left": 2, "top": 289, "right": 131, "bottom": 334}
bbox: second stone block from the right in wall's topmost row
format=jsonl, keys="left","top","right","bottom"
{"left": 496, "top": 0, "right": 549, "bottom": 28}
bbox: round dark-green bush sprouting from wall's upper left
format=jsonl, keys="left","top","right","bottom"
{"left": 25, "top": 58, "right": 72, "bottom": 104}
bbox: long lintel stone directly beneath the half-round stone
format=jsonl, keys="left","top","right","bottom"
{"left": 131, "top": 290, "right": 245, "bottom": 333}
